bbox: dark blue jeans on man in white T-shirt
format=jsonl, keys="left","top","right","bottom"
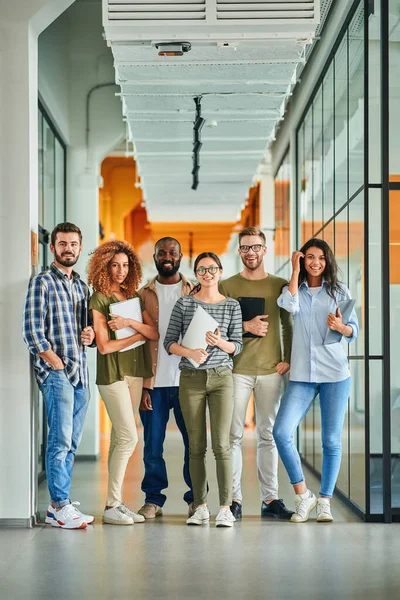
{"left": 140, "top": 387, "right": 193, "bottom": 506}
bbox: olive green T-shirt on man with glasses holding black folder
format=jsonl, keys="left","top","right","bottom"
{"left": 219, "top": 274, "right": 293, "bottom": 375}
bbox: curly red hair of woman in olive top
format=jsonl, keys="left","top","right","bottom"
{"left": 87, "top": 240, "right": 142, "bottom": 298}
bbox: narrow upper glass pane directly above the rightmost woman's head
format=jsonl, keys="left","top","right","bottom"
{"left": 313, "top": 89, "right": 324, "bottom": 235}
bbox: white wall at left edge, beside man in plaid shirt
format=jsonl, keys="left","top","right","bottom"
{"left": 0, "top": 0, "right": 75, "bottom": 525}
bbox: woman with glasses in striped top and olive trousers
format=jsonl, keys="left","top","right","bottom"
{"left": 164, "top": 252, "right": 242, "bottom": 527}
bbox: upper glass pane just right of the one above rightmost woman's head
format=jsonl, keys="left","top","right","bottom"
{"left": 323, "top": 64, "right": 335, "bottom": 223}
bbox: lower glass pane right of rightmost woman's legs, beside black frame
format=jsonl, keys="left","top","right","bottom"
{"left": 349, "top": 360, "right": 365, "bottom": 511}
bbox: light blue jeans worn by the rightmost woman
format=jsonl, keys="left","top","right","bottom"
{"left": 273, "top": 377, "right": 351, "bottom": 498}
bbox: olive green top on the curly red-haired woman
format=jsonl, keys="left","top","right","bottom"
{"left": 90, "top": 292, "right": 153, "bottom": 385}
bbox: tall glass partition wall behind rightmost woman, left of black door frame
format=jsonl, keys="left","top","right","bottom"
{"left": 297, "top": 4, "right": 366, "bottom": 511}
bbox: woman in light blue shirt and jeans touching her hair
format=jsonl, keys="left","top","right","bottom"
{"left": 274, "top": 238, "right": 358, "bottom": 523}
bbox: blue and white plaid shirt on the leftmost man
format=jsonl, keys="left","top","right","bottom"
{"left": 24, "top": 263, "right": 90, "bottom": 387}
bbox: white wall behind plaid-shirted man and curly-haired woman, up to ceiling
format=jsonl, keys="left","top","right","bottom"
{"left": 39, "top": 3, "right": 125, "bottom": 457}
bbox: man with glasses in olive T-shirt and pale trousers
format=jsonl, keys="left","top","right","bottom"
{"left": 220, "top": 227, "right": 293, "bottom": 519}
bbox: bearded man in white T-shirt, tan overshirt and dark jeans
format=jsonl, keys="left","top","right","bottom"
{"left": 138, "top": 237, "right": 194, "bottom": 519}
